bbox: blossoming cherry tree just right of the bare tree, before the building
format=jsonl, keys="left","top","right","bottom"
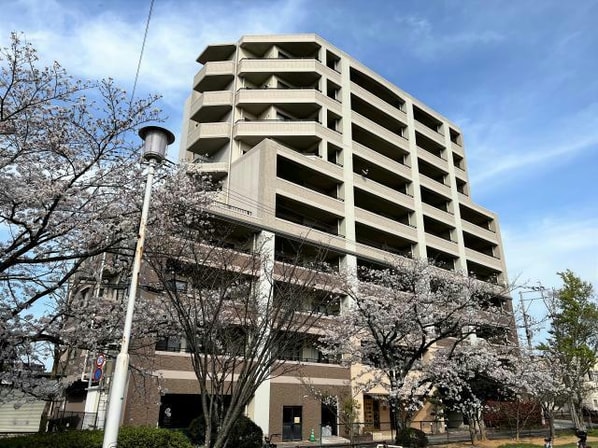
{"left": 324, "top": 258, "right": 513, "bottom": 442}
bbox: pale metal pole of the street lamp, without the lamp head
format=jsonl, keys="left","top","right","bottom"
{"left": 102, "top": 159, "right": 156, "bottom": 448}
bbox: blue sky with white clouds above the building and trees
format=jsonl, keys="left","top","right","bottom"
{"left": 0, "top": 0, "right": 598, "bottom": 306}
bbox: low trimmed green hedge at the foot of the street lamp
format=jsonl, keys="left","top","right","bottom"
{"left": 0, "top": 427, "right": 193, "bottom": 448}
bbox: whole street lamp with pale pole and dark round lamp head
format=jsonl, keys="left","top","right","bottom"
{"left": 102, "top": 126, "right": 174, "bottom": 448}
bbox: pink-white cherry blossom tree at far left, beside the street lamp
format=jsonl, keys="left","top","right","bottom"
{"left": 0, "top": 33, "right": 160, "bottom": 398}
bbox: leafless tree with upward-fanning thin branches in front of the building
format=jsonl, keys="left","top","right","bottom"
{"left": 148, "top": 209, "right": 338, "bottom": 448}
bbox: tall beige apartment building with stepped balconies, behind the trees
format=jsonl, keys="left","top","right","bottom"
{"left": 63, "top": 34, "right": 507, "bottom": 440}
